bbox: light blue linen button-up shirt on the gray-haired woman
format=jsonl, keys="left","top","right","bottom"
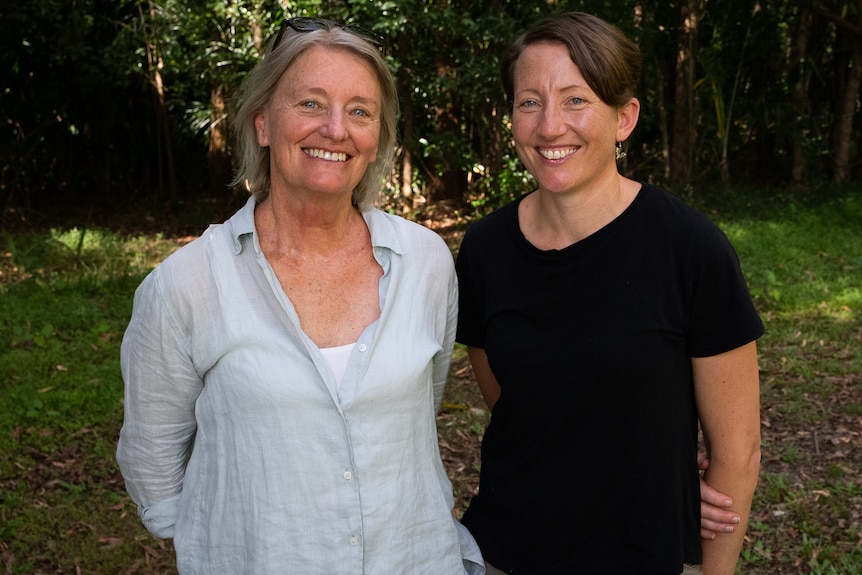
{"left": 117, "top": 199, "right": 484, "bottom": 575}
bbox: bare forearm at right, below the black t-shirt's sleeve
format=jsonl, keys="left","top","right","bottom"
{"left": 692, "top": 342, "right": 760, "bottom": 575}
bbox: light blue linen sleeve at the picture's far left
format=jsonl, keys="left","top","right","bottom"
{"left": 117, "top": 269, "right": 203, "bottom": 538}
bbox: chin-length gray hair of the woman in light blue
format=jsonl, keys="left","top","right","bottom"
{"left": 233, "top": 25, "right": 399, "bottom": 211}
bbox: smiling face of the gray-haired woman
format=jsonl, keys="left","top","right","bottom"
{"left": 255, "top": 47, "right": 382, "bottom": 205}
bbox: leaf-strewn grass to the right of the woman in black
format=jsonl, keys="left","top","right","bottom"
{"left": 704, "top": 190, "right": 862, "bottom": 575}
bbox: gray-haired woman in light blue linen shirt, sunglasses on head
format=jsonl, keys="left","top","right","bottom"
{"left": 117, "top": 18, "right": 484, "bottom": 575}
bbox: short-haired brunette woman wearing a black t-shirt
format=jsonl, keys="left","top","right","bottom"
{"left": 456, "top": 13, "right": 763, "bottom": 575}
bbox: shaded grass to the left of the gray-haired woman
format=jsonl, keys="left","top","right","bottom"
{"left": 0, "top": 230, "right": 181, "bottom": 574}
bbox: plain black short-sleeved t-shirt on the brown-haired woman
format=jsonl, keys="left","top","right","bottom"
{"left": 457, "top": 185, "right": 763, "bottom": 575}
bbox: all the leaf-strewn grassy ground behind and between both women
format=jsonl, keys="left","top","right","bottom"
{"left": 0, "top": 189, "right": 862, "bottom": 575}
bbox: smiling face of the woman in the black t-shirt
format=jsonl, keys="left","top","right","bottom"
{"left": 512, "top": 42, "right": 638, "bottom": 197}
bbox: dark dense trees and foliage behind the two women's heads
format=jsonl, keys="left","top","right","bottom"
{"left": 0, "top": 0, "right": 862, "bottom": 222}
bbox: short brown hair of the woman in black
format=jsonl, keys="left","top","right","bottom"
{"left": 500, "top": 12, "right": 641, "bottom": 108}
